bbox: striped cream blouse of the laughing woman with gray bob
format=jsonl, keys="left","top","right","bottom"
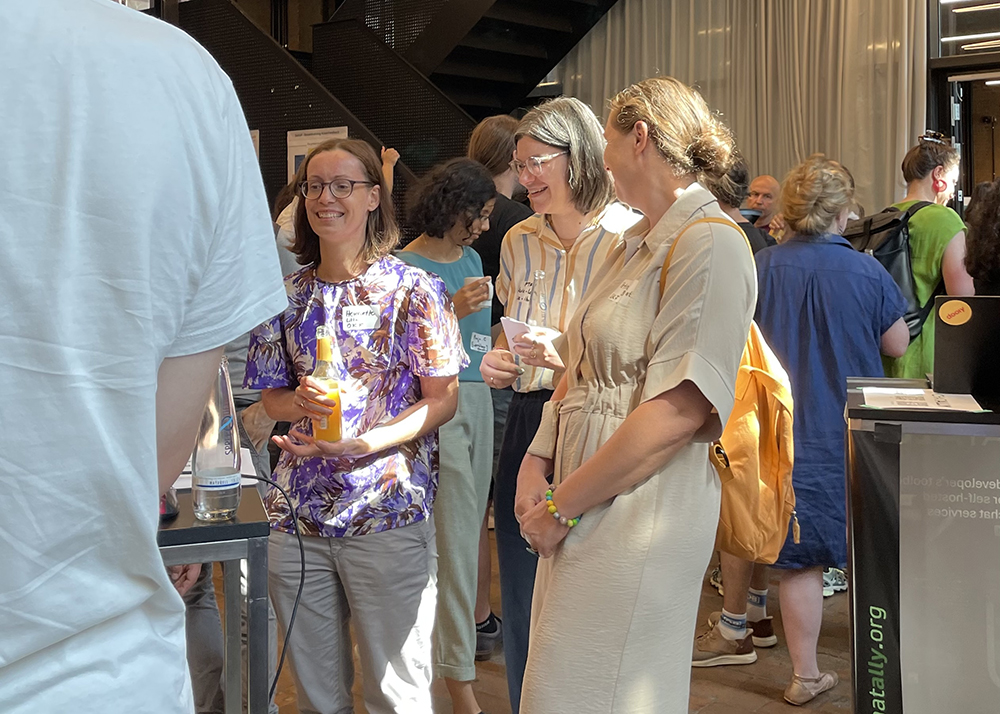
{"left": 496, "top": 203, "right": 645, "bottom": 392}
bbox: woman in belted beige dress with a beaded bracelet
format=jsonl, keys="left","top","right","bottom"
{"left": 515, "top": 77, "right": 756, "bottom": 714}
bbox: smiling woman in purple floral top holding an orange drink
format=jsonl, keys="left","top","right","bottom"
{"left": 245, "top": 140, "right": 468, "bottom": 714}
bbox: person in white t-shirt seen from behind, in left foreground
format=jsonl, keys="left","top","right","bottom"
{"left": 0, "top": 0, "right": 287, "bottom": 714}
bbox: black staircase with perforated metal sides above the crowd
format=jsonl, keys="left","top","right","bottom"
{"left": 156, "top": 0, "right": 616, "bottom": 198}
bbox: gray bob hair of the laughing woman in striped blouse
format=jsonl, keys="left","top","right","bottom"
{"left": 514, "top": 97, "right": 615, "bottom": 214}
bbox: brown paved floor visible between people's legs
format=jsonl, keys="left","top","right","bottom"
{"left": 246, "top": 544, "right": 851, "bottom": 714}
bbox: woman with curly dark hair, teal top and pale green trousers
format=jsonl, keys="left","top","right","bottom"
{"left": 398, "top": 158, "right": 496, "bottom": 714}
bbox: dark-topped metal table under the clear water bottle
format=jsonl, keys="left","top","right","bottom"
{"left": 157, "top": 486, "right": 271, "bottom": 714}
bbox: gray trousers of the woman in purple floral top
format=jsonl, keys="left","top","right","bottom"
{"left": 268, "top": 520, "right": 437, "bottom": 714}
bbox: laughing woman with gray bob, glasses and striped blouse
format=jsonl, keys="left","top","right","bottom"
{"left": 480, "top": 97, "right": 638, "bottom": 713}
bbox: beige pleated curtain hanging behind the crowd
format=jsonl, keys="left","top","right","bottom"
{"left": 556, "top": 0, "right": 927, "bottom": 212}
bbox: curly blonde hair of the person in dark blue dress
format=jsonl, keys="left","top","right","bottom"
{"left": 781, "top": 154, "right": 854, "bottom": 236}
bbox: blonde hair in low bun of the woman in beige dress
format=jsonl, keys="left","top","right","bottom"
{"left": 611, "top": 77, "right": 736, "bottom": 184}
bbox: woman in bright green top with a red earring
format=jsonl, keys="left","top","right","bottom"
{"left": 882, "top": 133, "right": 975, "bottom": 379}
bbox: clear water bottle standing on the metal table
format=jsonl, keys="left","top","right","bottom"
{"left": 191, "top": 357, "right": 241, "bottom": 521}
